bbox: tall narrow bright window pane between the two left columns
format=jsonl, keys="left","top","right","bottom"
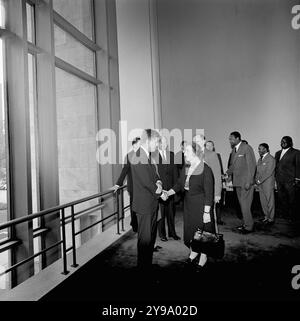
{"left": 28, "top": 54, "right": 40, "bottom": 273}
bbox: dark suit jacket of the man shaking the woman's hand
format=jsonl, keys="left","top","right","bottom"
{"left": 131, "top": 148, "right": 160, "bottom": 215}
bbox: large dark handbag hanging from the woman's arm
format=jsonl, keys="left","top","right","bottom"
{"left": 191, "top": 209, "right": 225, "bottom": 259}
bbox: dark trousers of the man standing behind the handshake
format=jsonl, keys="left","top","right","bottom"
{"left": 158, "top": 197, "right": 176, "bottom": 238}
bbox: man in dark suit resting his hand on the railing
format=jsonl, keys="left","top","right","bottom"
{"left": 112, "top": 137, "right": 140, "bottom": 232}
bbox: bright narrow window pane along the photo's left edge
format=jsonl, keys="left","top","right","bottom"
{"left": 0, "top": 38, "right": 9, "bottom": 291}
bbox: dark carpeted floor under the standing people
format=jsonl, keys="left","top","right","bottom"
{"left": 41, "top": 196, "right": 300, "bottom": 302}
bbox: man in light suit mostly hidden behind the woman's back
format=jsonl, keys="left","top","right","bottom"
{"left": 193, "top": 135, "right": 222, "bottom": 203}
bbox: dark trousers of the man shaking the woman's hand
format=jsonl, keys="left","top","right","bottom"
{"left": 136, "top": 210, "right": 157, "bottom": 269}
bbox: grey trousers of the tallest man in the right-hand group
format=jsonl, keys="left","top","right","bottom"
{"left": 236, "top": 186, "right": 254, "bottom": 230}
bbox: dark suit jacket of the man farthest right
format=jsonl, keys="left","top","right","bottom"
{"left": 275, "top": 147, "right": 300, "bottom": 183}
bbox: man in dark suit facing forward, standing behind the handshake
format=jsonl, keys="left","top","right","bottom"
{"left": 158, "top": 137, "right": 180, "bottom": 242}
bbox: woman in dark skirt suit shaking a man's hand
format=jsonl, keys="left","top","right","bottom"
{"left": 167, "top": 142, "right": 215, "bottom": 271}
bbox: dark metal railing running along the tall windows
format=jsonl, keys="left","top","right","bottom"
{"left": 0, "top": 185, "right": 129, "bottom": 276}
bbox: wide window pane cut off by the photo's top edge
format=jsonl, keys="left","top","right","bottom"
{"left": 53, "top": 0, "right": 93, "bottom": 39}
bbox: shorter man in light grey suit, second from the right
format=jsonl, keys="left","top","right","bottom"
{"left": 255, "top": 143, "right": 276, "bottom": 225}
